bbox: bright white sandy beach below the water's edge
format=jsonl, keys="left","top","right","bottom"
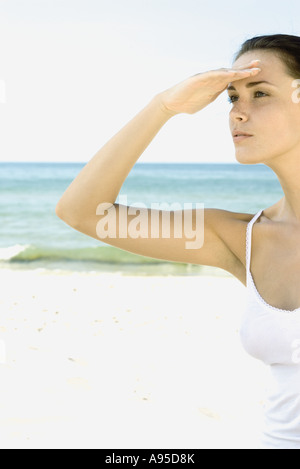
{"left": 0, "top": 269, "right": 267, "bottom": 449}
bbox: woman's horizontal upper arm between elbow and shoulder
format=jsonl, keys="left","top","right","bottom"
{"left": 57, "top": 204, "right": 249, "bottom": 273}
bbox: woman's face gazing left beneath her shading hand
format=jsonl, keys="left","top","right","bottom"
{"left": 228, "top": 50, "right": 300, "bottom": 166}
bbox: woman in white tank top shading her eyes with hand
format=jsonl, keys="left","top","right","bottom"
{"left": 56, "top": 35, "right": 300, "bottom": 449}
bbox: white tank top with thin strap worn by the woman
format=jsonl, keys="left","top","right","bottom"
{"left": 240, "top": 210, "right": 300, "bottom": 449}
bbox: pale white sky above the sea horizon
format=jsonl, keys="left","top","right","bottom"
{"left": 0, "top": 0, "right": 300, "bottom": 163}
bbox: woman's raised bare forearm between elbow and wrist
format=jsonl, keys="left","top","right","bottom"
{"left": 56, "top": 96, "right": 174, "bottom": 222}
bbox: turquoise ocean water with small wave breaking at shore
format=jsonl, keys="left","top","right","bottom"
{"left": 0, "top": 163, "right": 283, "bottom": 275}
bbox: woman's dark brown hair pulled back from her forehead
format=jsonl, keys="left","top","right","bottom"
{"left": 234, "top": 34, "right": 300, "bottom": 78}
